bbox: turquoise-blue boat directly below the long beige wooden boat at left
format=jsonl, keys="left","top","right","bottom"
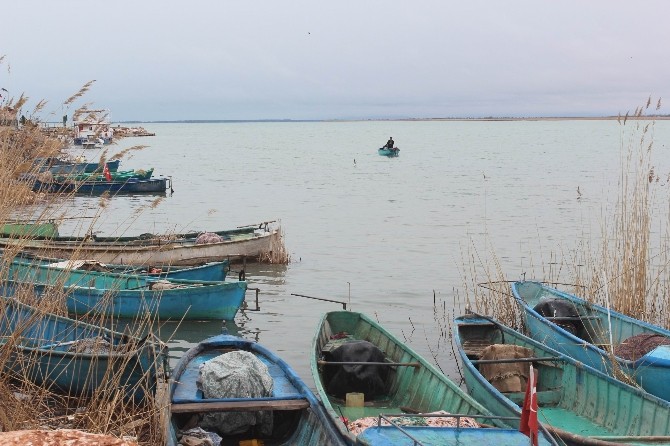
{"left": 4, "top": 254, "right": 247, "bottom": 320}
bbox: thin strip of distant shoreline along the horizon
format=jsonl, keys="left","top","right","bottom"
{"left": 118, "top": 115, "right": 670, "bottom": 124}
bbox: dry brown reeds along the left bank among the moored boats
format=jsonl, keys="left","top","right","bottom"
{"left": 0, "top": 89, "right": 167, "bottom": 445}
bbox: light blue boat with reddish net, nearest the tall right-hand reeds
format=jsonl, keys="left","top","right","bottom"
{"left": 512, "top": 281, "right": 670, "bottom": 401}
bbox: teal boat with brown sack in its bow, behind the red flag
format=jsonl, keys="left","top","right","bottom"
{"left": 454, "top": 315, "right": 670, "bottom": 445}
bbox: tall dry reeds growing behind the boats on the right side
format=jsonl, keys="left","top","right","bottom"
{"left": 457, "top": 98, "right": 670, "bottom": 328}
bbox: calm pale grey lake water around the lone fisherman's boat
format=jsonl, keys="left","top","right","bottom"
{"left": 55, "top": 120, "right": 670, "bottom": 382}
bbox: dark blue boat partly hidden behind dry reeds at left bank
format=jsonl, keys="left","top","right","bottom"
{"left": 0, "top": 298, "right": 168, "bottom": 401}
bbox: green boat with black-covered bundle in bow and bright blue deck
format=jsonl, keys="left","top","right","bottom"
{"left": 310, "top": 311, "right": 554, "bottom": 445}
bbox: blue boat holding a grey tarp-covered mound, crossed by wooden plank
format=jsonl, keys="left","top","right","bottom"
{"left": 167, "top": 335, "right": 346, "bottom": 446}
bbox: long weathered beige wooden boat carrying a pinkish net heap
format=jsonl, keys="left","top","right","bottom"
{"left": 0, "top": 223, "right": 282, "bottom": 266}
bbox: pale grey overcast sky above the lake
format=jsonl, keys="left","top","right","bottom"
{"left": 0, "top": 0, "right": 670, "bottom": 121}
